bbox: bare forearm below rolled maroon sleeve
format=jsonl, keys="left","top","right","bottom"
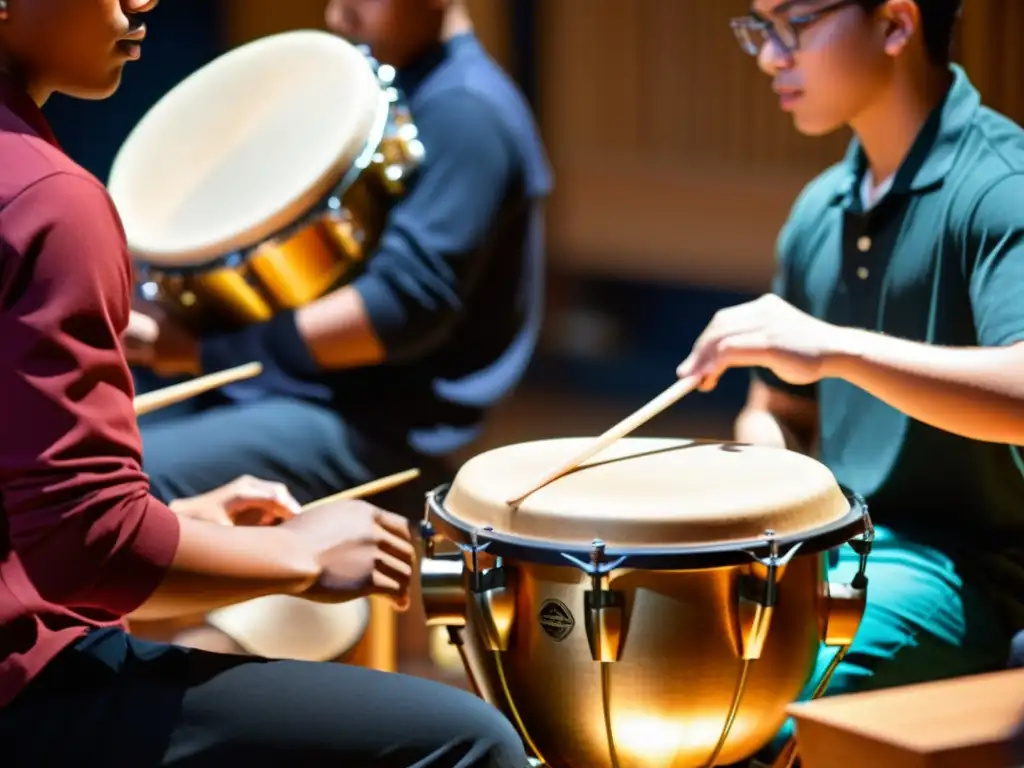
{"left": 130, "top": 516, "right": 319, "bottom": 621}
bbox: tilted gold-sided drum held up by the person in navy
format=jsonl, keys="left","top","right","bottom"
{"left": 109, "top": 30, "right": 424, "bottom": 333}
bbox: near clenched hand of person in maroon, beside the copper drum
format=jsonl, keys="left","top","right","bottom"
{"left": 281, "top": 501, "right": 416, "bottom": 610}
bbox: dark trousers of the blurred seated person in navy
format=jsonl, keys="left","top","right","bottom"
{"left": 135, "top": 371, "right": 451, "bottom": 516}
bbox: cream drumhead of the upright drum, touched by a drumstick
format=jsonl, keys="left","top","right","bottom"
{"left": 443, "top": 437, "right": 850, "bottom": 547}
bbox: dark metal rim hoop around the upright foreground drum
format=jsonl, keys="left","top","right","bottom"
{"left": 421, "top": 482, "right": 872, "bottom": 570}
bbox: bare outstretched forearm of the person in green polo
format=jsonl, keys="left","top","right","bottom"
{"left": 824, "top": 330, "right": 1024, "bottom": 445}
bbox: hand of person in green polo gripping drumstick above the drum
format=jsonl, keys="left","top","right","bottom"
{"left": 676, "top": 294, "right": 852, "bottom": 392}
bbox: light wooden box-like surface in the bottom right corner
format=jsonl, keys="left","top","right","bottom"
{"left": 788, "top": 670, "right": 1024, "bottom": 768}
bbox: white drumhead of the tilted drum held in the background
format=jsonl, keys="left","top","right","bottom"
{"left": 109, "top": 30, "right": 383, "bottom": 266}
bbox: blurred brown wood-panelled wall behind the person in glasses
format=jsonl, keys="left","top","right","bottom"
{"left": 539, "top": 0, "right": 1024, "bottom": 290}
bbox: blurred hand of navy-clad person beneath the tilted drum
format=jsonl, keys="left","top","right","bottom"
{"left": 123, "top": 303, "right": 200, "bottom": 376}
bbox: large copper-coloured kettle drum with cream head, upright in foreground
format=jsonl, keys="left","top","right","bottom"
{"left": 422, "top": 437, "right": 872, "bottom": 768}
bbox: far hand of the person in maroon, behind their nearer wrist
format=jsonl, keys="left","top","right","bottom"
{"left": 170, "top": 475, "right": 301, "bottom": 525}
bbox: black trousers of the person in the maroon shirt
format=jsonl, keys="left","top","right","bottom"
{"left": 0, "top": 630, "right": 527, "bottom": 768}
